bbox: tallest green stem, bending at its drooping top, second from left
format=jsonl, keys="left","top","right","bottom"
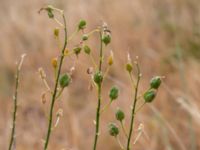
{"left": 44, "top": 13, "right": 67, "bottom": 150}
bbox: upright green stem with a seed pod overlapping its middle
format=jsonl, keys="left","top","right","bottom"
{"left": 93, "top": 31, "right": 103, "bottom": 150}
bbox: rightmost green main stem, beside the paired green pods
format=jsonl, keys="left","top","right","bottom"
{"left": 126, "top": 63, "right": 141, "bottom": 150}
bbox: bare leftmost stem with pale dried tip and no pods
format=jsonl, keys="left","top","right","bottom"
{"left": 8, "top": 54, "right": 25, "bottom": 150}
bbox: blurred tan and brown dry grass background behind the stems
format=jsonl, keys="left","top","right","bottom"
{"left": 0, "top": 0, "right": 200, "bottom": 150}
